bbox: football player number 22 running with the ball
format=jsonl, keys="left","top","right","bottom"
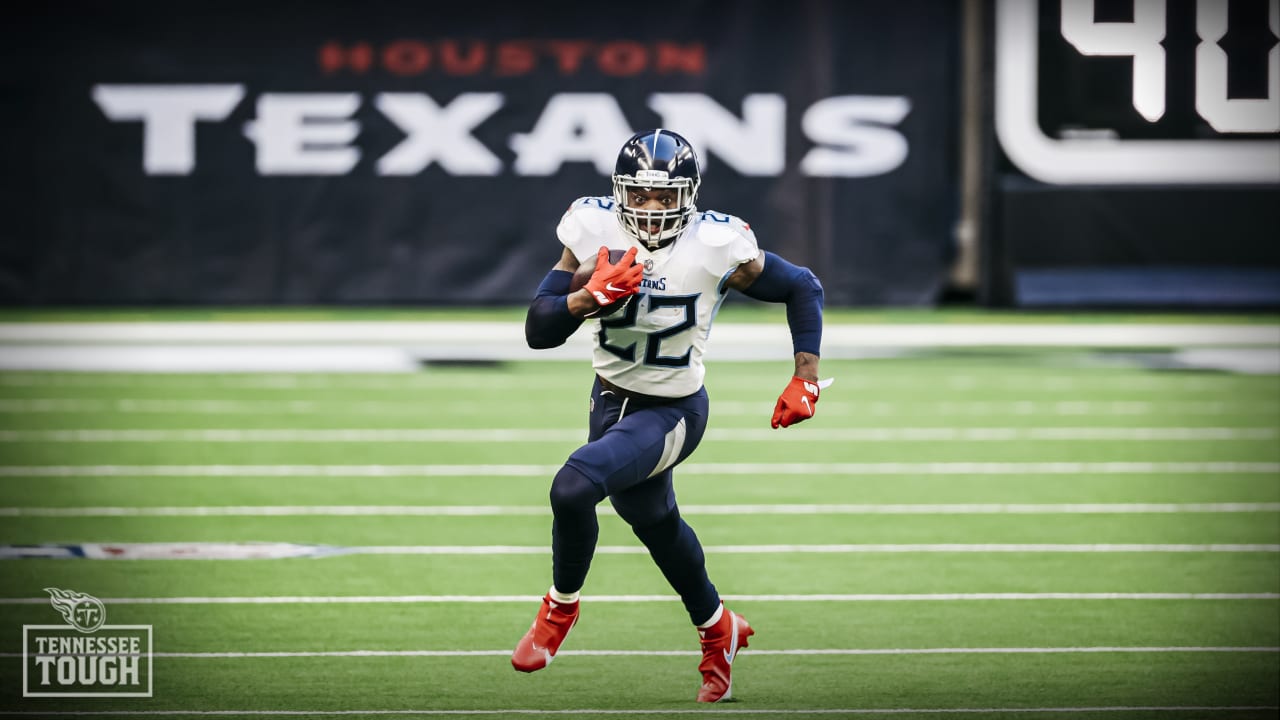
{"left": 511, "top": 129, "right": 826, "bottom": 702}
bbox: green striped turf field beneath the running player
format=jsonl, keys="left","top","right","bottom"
{"left": 0, "top": 351, "right": 1280, "bottom": 719}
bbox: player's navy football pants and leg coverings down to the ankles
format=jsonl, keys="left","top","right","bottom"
{"left": 550, "top": 379, "right": 719, "bottom": 624}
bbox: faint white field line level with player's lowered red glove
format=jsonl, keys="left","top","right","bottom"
{"left": 0, "top": 394, "right": 1280, "bottom": 417}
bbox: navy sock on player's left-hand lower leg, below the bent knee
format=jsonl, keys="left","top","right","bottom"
{"left": 552, "top": 465, "right": 604, "bottom": 593}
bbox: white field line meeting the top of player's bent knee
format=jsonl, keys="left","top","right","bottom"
{"left": 0, "top": 461, "right": 1280, "bottom": 478}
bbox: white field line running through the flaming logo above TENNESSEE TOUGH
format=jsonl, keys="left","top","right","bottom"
{"left": 0, "top": 592, "right": 1280, "bottom": 605}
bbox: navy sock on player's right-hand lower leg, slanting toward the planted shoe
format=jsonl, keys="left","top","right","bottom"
{"left": 631, "top": 510, "right": 719, "bottom": 625}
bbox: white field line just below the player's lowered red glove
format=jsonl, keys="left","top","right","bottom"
{"left": 0, "top": 427, "right": 1280, "bottom": 443}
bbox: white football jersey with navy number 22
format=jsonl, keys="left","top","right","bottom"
{"left": 556, "top": 197, "right": 760, "bottom": 397}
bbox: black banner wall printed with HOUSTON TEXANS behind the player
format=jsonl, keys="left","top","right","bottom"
{"left": 0, "top": 0, "right": 959, "bottom": 305}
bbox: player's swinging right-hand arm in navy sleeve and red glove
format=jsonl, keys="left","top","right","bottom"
{"left": 726, "top": 252, "right": 823, "bottom": 428}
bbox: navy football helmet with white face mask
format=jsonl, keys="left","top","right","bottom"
{"left": 613, "top": 128, "right": 701, "bottom": 250}
